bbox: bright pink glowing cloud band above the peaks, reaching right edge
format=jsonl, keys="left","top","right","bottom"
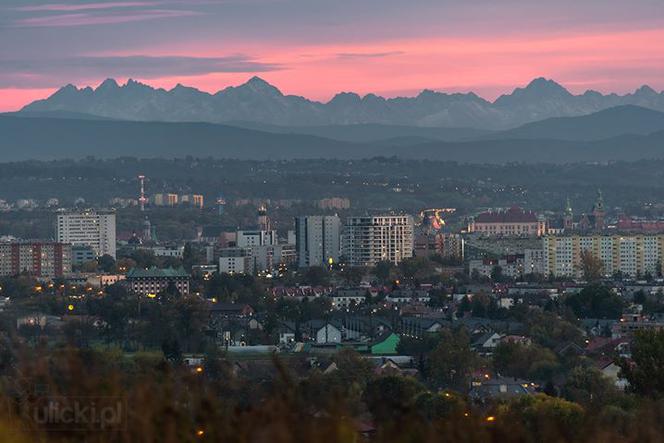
{"left": 137, "top": 29, "right": 664, "bottom": 100}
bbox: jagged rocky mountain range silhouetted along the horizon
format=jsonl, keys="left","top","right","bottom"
{"left": 24, "top": 77, "right": 664, "bottom": 130}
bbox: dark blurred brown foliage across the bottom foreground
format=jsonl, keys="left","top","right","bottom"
{"left": 0, "top": 336, "right": 664, "bottom": 443}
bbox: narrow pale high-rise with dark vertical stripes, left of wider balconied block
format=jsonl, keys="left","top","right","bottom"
{"left": 295, "top": 215, "right": 341, "bottom": 268}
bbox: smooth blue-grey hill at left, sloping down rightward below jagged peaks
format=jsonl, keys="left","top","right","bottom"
{"left": 0, "top": 116, "right": 357, "bottom": 161}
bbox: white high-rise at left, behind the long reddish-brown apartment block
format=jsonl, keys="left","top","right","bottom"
{"left": 57, "top": 210, "right": 115, "bottom": 258}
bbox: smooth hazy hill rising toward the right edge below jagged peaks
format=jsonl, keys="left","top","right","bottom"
{"left": 492, "top": 105, "right": 664, "bottom": 140}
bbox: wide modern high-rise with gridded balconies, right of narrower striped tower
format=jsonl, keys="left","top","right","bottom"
{"left": 342, "top": 215, "right": 414, "bottom": 266}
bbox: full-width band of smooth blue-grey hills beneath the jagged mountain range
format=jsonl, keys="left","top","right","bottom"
{"left": 0, "top": 116, "right": 664, "bottom": 163}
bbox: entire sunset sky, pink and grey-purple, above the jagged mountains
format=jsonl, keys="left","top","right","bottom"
{"left": 0, "top": 0, "right": 664, "bottom": 111}
